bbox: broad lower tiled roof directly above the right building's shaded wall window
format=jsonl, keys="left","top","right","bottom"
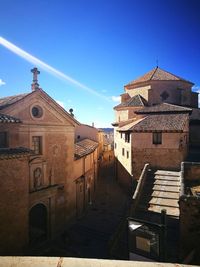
{"left": 129, "top": 114, "right": 188, "bottom": 132}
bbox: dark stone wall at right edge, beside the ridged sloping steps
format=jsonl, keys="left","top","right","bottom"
{"left": 179, "top": 162, "right": 200, "bottom": 262}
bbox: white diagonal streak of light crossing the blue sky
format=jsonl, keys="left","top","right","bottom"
{"left": 0, "top": 36, "right": 110, "bottom": 102}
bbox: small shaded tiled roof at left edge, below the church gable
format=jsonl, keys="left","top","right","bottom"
{"left": 0, "top": 147, "right": 34, "bottom": 159}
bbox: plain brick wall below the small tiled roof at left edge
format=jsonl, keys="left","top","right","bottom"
{"left": 0, "top": 158, "right": 29, "bottom": 255}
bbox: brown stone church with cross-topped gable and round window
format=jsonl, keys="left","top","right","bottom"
{"left": 0, "top": 68, "right": 99, "bottom": 255}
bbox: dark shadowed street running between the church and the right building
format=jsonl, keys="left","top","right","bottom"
{"left": 31, "top": 161, "right": 128, "bottom": 259}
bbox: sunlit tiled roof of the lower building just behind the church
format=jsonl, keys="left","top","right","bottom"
{"left": 75, "top": 139, "right": 98, "bottom": 159}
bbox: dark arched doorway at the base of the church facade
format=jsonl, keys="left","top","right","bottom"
{"left": 29, "top": 203, "right": 47, "bottom": 245}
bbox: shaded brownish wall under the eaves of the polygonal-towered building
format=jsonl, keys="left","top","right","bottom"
{"left": 132, "top": 132, "right": 188, "bottom": 179}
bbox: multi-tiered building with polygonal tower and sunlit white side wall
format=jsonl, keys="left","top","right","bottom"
{"left": 113, "top": 67, "right": 200, "bottom": 188}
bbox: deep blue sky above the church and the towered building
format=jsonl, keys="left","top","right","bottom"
{"left": 0, "top": 0, "right": 200, "bottom": 127}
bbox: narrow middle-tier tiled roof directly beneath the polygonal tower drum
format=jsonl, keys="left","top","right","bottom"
{"left": 135, "top": 103, "right": 192, "bottom": 114}
